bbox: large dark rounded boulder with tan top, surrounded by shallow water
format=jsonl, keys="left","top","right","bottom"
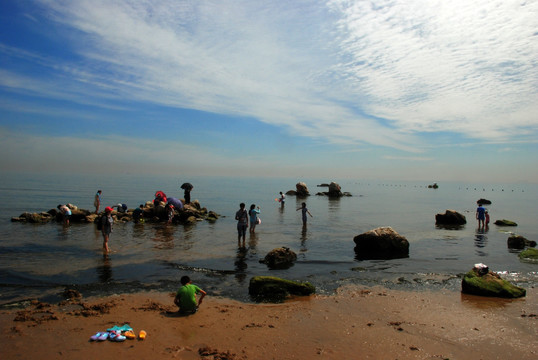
{"left": 353, "top": 227, "right": 409, "bottom": 260}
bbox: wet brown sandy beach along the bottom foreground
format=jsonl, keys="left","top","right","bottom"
{"left": 0, "top": 287, "right": 538, "bottom": 360}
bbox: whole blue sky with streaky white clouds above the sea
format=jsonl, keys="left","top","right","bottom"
{"left": 0, "top": 0, "right": 538, "bottom": 183}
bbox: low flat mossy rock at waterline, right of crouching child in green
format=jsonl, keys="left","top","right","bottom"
{"left": 248, "top": 276, "right": 316, "bottom": 302}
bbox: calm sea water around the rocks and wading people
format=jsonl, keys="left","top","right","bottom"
{"left": 0, "top": 174, "right": 538, "bottom": 303}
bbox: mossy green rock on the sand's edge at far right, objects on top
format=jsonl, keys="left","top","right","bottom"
{"left": 461, "top": 268, "right": 526, "bottom": 298}
